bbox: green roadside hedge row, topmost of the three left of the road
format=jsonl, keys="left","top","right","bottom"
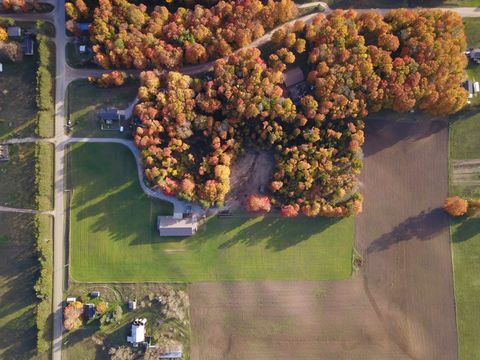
{"left": 37, "top": 34, "right": 55, "bottom": 138}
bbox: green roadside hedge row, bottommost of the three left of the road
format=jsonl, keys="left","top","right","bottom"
{"left": 34, "top": 215, "right": 53, "bottom": 353}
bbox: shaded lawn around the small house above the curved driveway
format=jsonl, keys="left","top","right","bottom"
{"left": 67, "top": 80, "right": 139, "bottom": 137}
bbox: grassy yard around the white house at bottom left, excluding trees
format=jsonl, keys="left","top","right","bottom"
{"left": 62, "top": 283, "right": 190, "bottom": 360}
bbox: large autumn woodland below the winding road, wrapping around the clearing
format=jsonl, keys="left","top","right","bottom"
{"left": 135, "top": 10, "right": 467, "bottom": 216}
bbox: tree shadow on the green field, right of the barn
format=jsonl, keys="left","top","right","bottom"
{"left": 218, "top": 217, "right": 340, "bottom": 251}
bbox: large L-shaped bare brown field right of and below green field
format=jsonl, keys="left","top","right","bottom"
{"left": 189, "top": 120, "right": 457, "bottom": 360}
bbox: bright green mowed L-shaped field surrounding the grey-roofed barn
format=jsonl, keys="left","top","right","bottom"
{"left": 70, "top": 143, "right": 353, "bottom": 282}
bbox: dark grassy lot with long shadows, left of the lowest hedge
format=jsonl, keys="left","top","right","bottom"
{"left": 0, "top": 213, "right": 38, "bottom": 359}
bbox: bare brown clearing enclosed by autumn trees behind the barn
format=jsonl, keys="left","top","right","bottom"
{"left": 225, "top": 150, "right": 275, "bottom": 211}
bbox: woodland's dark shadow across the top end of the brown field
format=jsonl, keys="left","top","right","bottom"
{"left": 363, "top": 111, "right": 448, "bottom": 157}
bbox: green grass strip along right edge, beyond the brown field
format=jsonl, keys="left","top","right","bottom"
{"left": 449, "top": 108, "right": 480, "bottom": 360}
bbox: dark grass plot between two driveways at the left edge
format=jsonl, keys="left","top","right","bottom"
{"left": 0, "top": 143, "right": 35, "bottom": 209}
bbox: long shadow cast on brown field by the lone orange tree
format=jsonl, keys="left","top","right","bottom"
{"left": 367, "top": 208, "right": 448, "bottom": 254}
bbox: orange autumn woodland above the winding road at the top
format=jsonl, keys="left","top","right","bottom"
{"left": 65, "top": 0, "right": 297, "bottom": 70}
